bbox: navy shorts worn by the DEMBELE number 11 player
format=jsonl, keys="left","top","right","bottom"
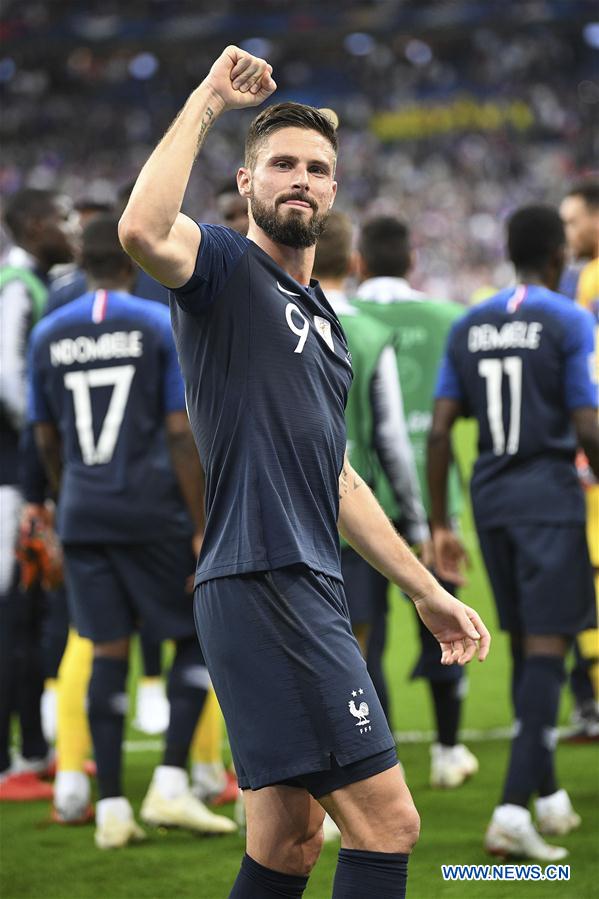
{"left": 478, "top": 523, "right": 597, "bottom": 636}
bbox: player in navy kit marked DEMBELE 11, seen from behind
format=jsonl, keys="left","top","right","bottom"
{"left": 428, "top": 206, "right": 599, "bottom": 861}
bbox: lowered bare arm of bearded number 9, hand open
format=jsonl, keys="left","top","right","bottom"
{"left": 338, "top": 457, "right": 491, "bottom": 665}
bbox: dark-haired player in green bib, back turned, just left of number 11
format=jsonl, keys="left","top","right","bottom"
{"left": 354, "top": 216, "right": 478, "bottom": 787}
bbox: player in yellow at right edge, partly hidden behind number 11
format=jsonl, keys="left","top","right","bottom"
{"left": 560, "top": 179, "right": 599, "bottom": 741}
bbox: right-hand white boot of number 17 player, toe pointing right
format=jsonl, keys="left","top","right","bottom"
{"left": 140, "top": 765, "right": 237, "bottom": 834}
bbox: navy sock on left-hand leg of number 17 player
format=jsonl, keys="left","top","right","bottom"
{"left": 87, "top": 656, "right": 128, "bottom": 799}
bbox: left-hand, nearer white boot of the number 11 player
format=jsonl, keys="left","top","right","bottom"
{"left": 484, "top": 804, "right": 568, "bottom": 862}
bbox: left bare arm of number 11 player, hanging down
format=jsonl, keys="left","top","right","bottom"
{"left": 427, "top": 399, "right": 468, "bottom": 586}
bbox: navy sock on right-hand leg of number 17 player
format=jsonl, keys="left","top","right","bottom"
{"left": 162, "top": 636, "right": 210, "bottom": 768}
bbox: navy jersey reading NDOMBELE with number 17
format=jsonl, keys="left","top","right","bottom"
{"left": 29, "top": 290, "right": 191, "bottom": 543}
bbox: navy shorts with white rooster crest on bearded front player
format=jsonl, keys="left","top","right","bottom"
{"left": 194, "top": 565, "right": 397, "bottom": 796}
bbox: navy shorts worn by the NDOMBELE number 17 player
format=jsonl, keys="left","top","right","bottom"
{"left": 64, "top": 539, "right": 195, "bottom": 643}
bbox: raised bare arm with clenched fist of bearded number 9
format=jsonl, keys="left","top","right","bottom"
{"left": 119, "top": 46, "right": 276, "bottom": 288}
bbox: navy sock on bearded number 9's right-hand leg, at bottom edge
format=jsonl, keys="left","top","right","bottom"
{"left": 333, "top": 849, "right": 409, "bottom": 899}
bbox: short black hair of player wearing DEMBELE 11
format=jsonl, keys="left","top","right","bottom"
{"left": 507, "top": 205, "right": 566, "bottom": 271}
